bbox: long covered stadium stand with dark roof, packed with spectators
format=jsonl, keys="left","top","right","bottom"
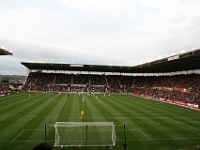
{"left": 22, "top": 50, "right": 200, "bottom": 110}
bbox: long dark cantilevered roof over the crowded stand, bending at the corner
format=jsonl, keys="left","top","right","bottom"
{"left": 21, "top": 49, "right": 200, "bottom": 73}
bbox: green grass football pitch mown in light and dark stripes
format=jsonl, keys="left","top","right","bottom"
{"left": 0, "top": 93, "right": 200, "bottom": 150}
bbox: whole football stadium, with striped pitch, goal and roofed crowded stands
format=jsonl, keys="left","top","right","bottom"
{"left": 0, "top": 49, "right": 200, "bottom": 150}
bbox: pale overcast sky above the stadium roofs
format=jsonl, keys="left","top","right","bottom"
{"left": 0, "top": 0, "right": 200, "bottom": 75}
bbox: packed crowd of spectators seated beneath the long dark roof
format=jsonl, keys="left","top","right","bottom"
{"left": 23, "top": 72, "right": 200, "bottom": 104}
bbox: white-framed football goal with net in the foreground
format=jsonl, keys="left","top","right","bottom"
{"left": 54, "top": 122, "right": 116, "bottom": 147}
